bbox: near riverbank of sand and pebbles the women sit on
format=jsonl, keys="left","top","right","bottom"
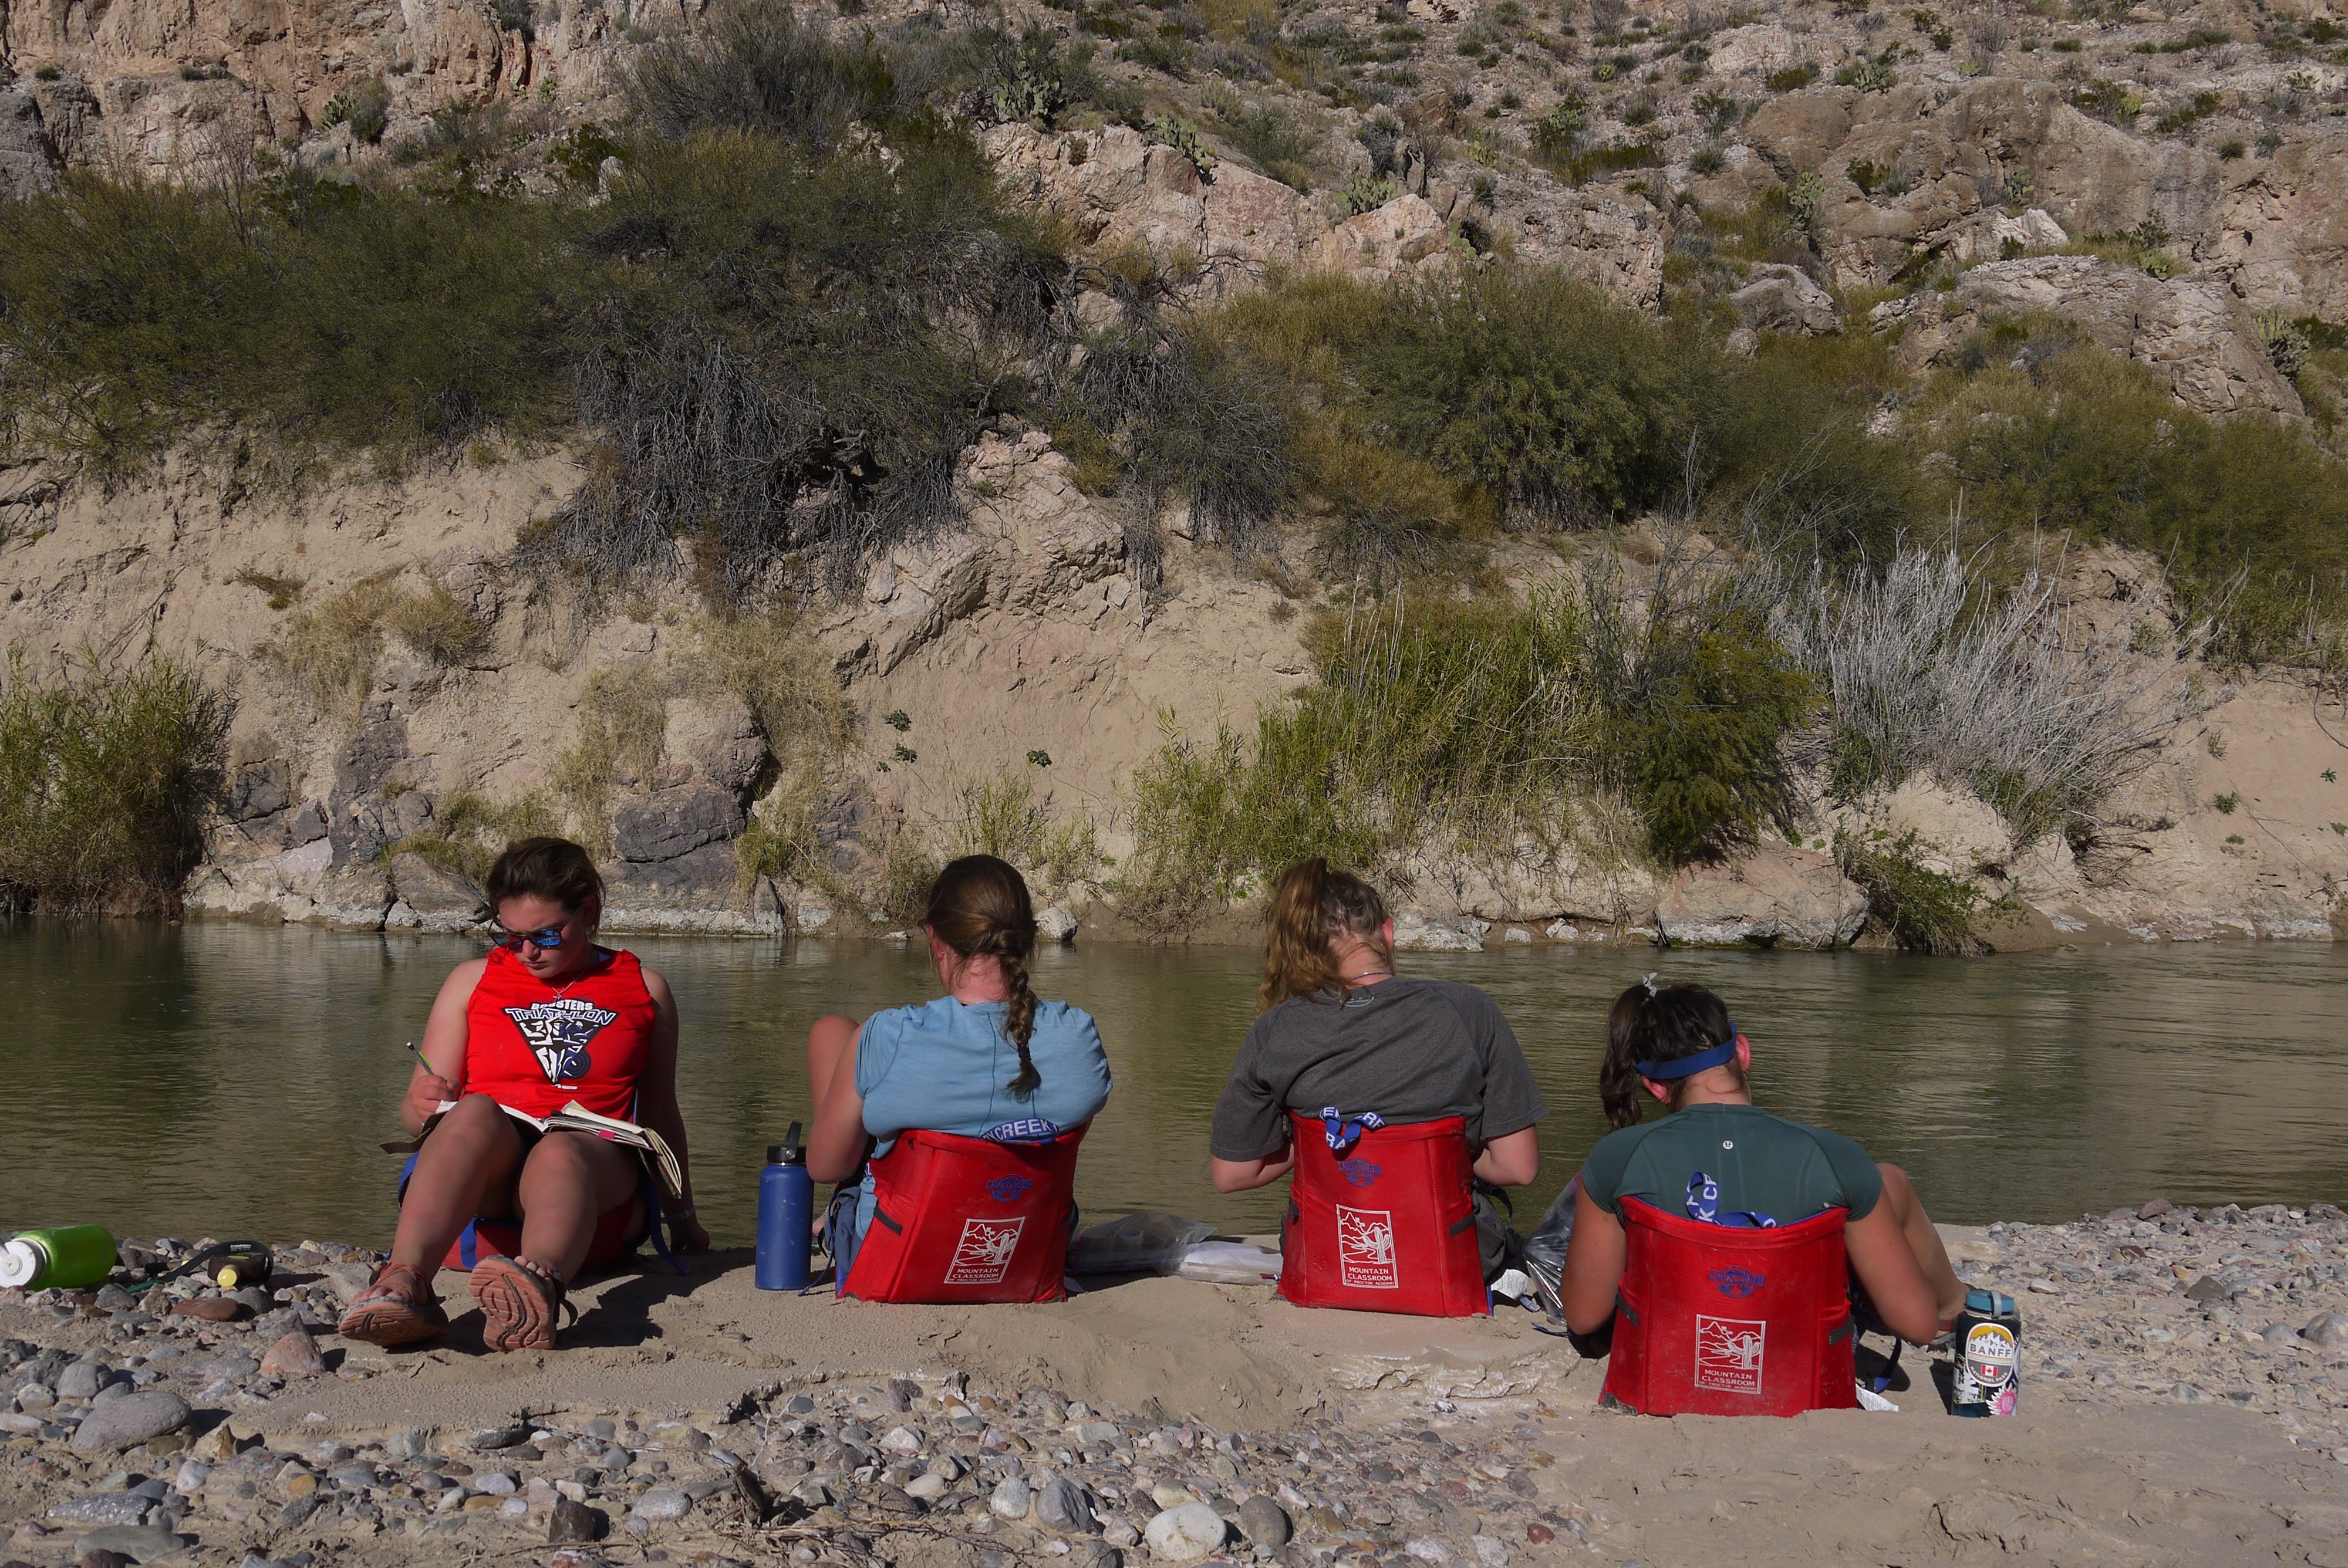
{"left": 0, "top": 1204, "right": 2348, "bottom": 1568}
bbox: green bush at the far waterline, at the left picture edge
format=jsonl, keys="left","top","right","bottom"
{"left": 0, "top": 655, "right": 232, "bottom": 913}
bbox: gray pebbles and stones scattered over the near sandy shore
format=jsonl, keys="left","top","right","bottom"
{"left": 0, "top": 1199, "right": 2348, "bottom": 1568}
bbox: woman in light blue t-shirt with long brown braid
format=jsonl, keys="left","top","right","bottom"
{"left": 808, "top": 854, "right": 1111, "bottom": 1253}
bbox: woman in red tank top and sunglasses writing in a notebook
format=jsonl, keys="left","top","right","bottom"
{"left": 338, "top": 838, "right": 709, "bottom": 1350}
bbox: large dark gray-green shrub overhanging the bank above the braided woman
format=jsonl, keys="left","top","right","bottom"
{"left": 538, "top": 122, "right": 1054, "bottom": 599}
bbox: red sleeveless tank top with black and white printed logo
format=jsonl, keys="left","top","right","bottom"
{"left": 465, "top": 948, "right": 653, "bottom": 1120}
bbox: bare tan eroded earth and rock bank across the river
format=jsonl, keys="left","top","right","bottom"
{"left": 0, "top": 444, "right": 2348, "bottom": 948}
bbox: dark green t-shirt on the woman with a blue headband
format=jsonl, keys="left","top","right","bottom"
{"left": 1583, "top": 1106, "right": 1883, "bottom": 1225}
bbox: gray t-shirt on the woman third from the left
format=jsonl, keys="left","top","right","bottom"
{"left": 1214, "top": 979, "right": 1550, "bottom": 1160}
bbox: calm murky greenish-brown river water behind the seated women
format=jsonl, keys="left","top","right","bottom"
{"left": 0, "top": 920, "right": 2348, "bottom": 1246}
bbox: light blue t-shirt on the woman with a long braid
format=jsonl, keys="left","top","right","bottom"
{"left": 857, "top": 995, "right": 1111, "bottom": 1242}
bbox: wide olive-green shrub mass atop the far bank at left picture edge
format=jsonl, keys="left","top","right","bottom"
{"left": 0, "top": 176, "right": 578, "bottom": 477}
